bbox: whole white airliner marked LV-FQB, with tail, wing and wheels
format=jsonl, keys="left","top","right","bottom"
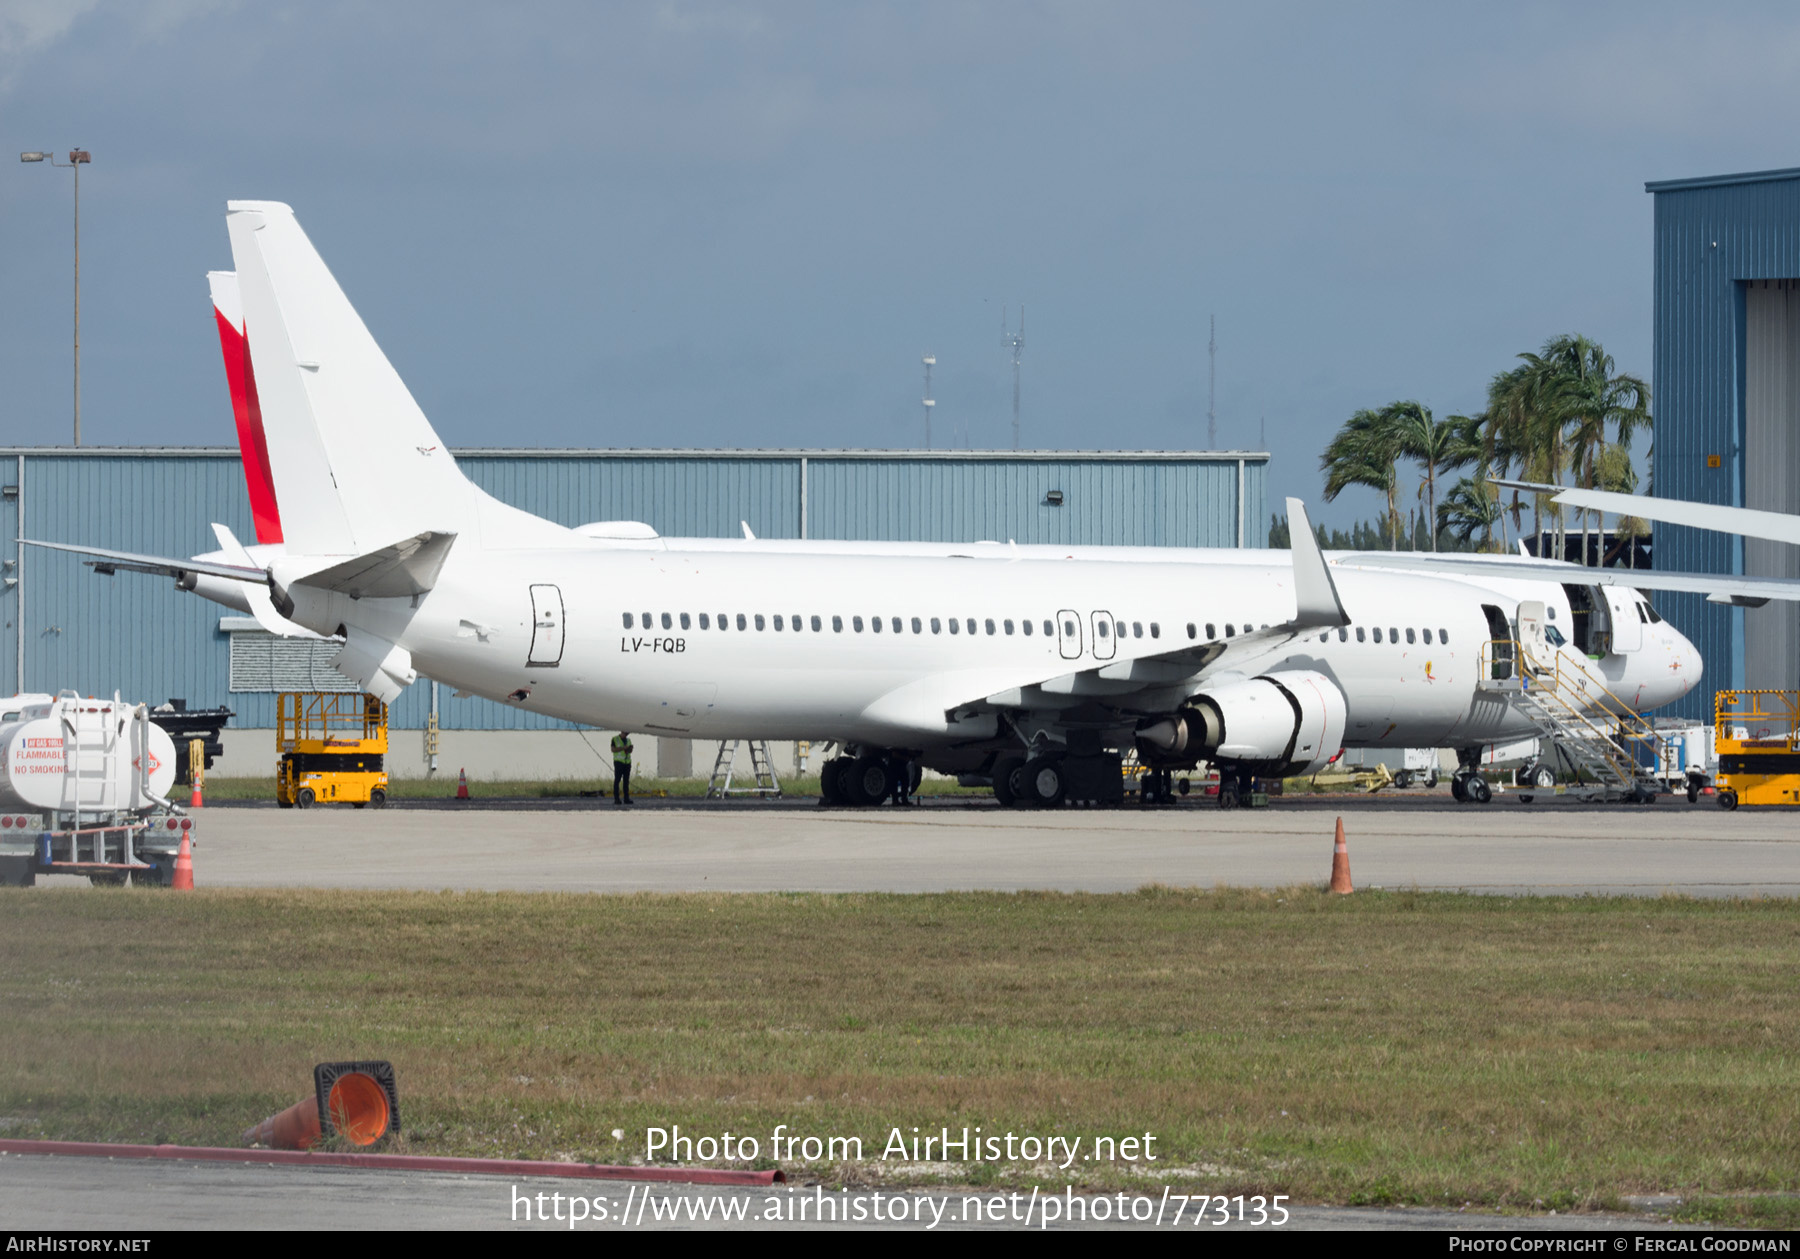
{"left": 24, "top": 202, "right": 1701, "bottom": 807}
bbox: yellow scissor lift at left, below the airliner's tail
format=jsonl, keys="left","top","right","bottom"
{"left": 275, "top": 692, "right": 387, "bottom": 809}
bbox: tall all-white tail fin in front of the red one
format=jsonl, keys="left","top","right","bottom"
{"left": 225, "top": 202, "right": 525, "bottom": 555}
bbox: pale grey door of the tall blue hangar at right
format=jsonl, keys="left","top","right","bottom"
{"left": 1742, "top": 279, "right": 1800, "bottom": 690}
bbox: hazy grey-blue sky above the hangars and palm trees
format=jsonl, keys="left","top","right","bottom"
{"left": 0, "top": 0, "right": 1800, "bottom": 524}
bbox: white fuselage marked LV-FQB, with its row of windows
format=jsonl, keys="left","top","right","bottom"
{"left": 261, "top": 539, "right": 1699, "bottom": 749}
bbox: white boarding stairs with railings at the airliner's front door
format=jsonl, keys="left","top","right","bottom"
{"left": 1480, "top": 639, "right": 1665, "bottom": 800}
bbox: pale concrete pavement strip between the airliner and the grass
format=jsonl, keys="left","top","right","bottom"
{"left": 77, "top": 796, "right": 1800, "bottom": 897}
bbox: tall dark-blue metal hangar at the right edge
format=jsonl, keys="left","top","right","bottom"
{"left": 1645, "top": 169, "right": 1800, "bottom": 719}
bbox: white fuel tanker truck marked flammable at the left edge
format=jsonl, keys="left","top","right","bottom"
{"left": 0, "top": 692, "right": 193, "bottom": 888}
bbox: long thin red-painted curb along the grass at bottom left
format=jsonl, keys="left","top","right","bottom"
{"left": 0, "top": 1140, "right": 787, "bottom": 1185}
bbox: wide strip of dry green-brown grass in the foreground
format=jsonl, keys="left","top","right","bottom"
{"left": 0, "top": 888, "right": 1800, "bottom": 1223}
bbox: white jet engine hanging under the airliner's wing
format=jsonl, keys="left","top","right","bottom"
{"left": 1138, "top": 668, "right": 1346, "bottom": 774}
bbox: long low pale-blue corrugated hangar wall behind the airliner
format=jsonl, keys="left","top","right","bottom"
{"left": 0, "top": 448, "right": 1269, "bottom": 729}
